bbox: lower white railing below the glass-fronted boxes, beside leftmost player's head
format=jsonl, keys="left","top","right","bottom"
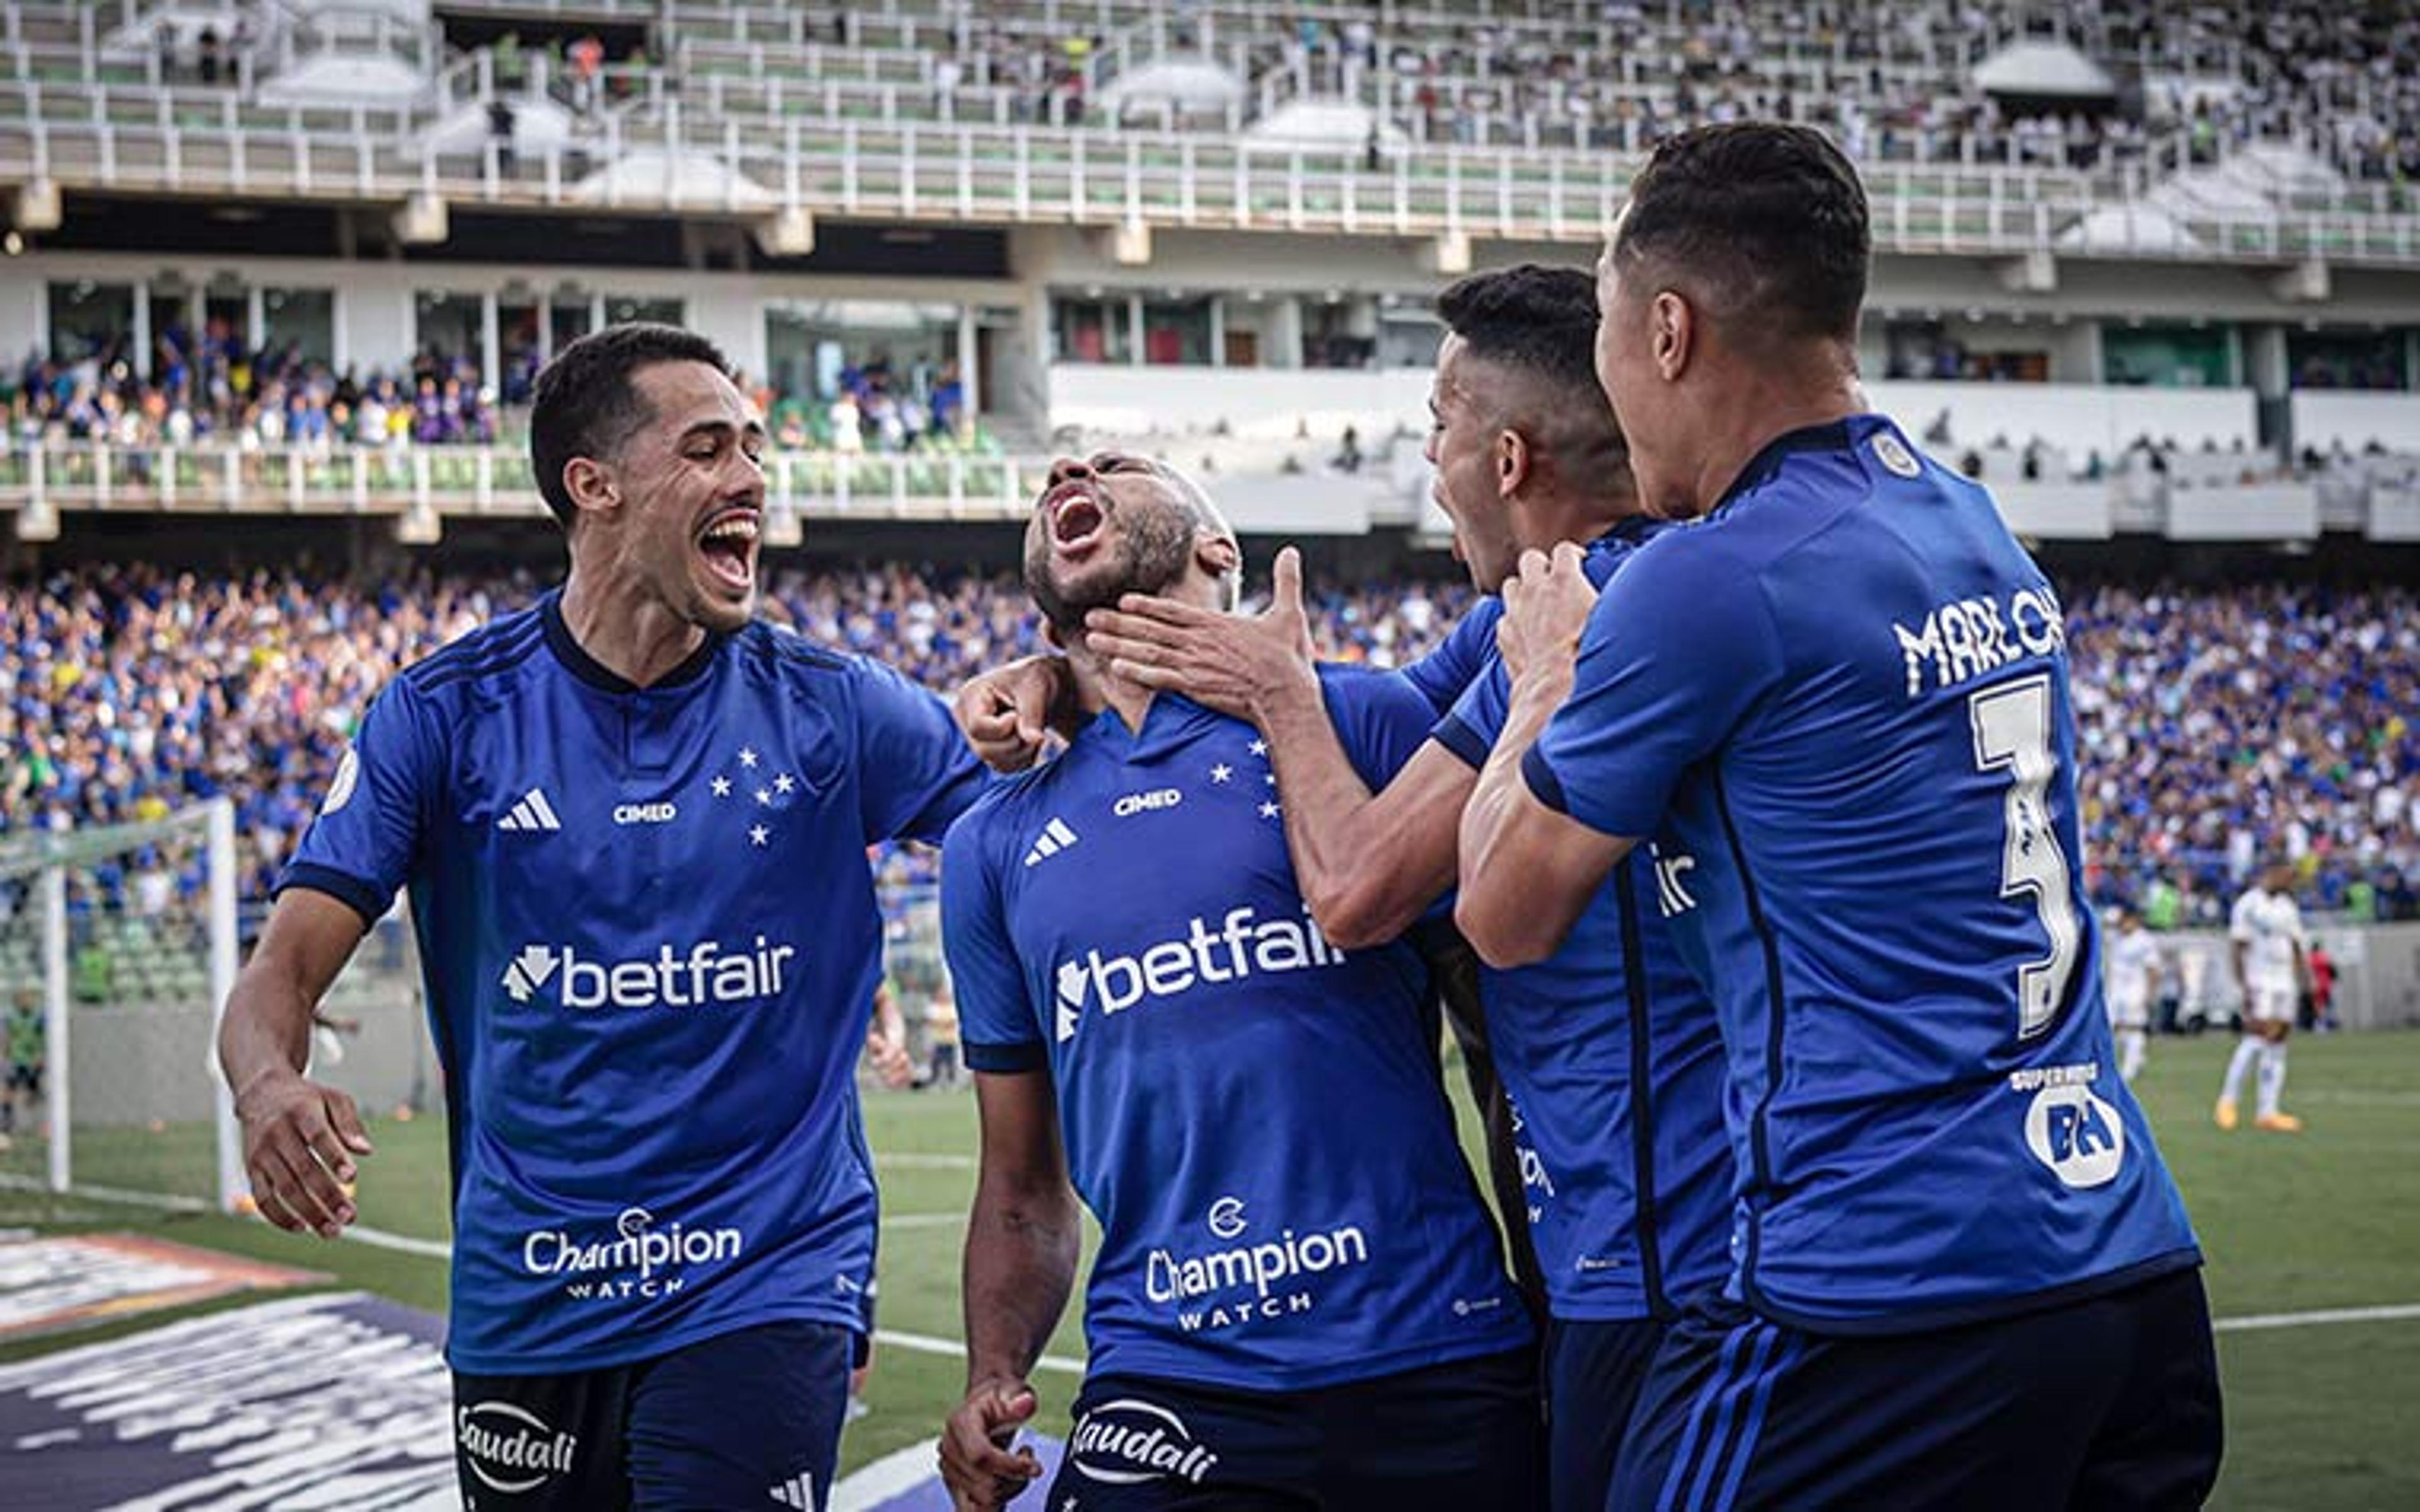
{"left": 0, "top": 440, "right": 1048, "bottom": 520}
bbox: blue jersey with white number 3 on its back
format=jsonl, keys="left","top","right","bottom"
{"left": 1524, "top": 416, "right": 2200, "bottom": 1331}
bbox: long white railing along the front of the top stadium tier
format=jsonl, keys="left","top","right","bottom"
{"left": 19, "top": 113, "right": 2420, "bottom": 266}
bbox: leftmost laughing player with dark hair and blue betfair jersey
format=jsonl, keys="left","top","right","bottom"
{"left": 220, "top": 324, "right": 985, "bottom": 1509}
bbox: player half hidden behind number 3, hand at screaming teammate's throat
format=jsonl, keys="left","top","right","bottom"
{"left": 1086, "top": 266, "right": 1732, "bottom": 1512}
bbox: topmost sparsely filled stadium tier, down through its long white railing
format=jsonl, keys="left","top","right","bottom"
{"left": 0, "top": 0, "right": 2420, "bottom": 266}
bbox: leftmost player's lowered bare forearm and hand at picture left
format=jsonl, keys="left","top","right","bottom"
{"left": 218, "top": 888, "right": 371, "bottom": 1239}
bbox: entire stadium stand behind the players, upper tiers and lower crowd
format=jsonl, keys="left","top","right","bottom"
{"left": 0, "top": 0, "right": 2420, "bottom": 938}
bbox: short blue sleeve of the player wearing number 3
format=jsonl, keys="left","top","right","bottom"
{"left": 1522, "top": 532, "right": 1781, "bottom": 839}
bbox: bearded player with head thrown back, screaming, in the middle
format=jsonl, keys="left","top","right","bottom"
{"left": 942, "top": 455, "right": 1536, "bottom": 1512}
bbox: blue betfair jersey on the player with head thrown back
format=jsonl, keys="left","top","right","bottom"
{"left": 942, "top": 670, "right": 1530, "bottom": 1391}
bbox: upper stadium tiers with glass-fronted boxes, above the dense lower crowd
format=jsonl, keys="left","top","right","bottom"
{"left": 0, "top": 0, "right": 2420, "bottom": 542}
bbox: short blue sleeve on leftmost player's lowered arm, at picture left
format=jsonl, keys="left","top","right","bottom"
{"left": 276, "top": 677, "right": 443, "bottom": 924}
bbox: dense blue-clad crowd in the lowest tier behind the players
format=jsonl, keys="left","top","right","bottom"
{"left": 0, "top": 566, "right": 2420, "bottom": 924}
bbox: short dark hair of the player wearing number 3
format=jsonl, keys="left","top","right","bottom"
{"left": 1614, "top": 121, "right": 1873, "bottom": 341}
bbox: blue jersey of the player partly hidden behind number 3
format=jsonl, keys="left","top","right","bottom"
{"left": 1438, "top": 520, "right": 1731, "bottom": 1321}
